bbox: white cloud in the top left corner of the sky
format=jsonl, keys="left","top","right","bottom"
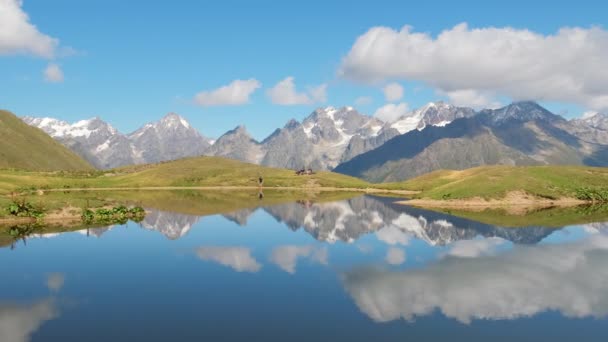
{"left": 0, "top": 0, "right": 59, "bottom": 58}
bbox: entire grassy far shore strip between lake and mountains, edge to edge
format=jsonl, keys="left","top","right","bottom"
{"left": 0, "top": 157, "right": 608, "bottom": 216}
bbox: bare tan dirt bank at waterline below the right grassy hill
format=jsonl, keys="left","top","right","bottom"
{"left": 397, "top": 191, "right": 588, "bottom": 215}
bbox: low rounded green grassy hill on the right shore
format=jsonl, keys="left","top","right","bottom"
{"left": 392, "top": 166, "right": 608, "bottom": 200}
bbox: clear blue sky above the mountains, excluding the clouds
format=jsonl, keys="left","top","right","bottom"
{"left": 0, "top": 0, "right": 608, "bottom": 139}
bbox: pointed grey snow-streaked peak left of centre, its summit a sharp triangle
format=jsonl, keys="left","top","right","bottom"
{"left": 127, "top": 113, "right": 210, "bottom": 163}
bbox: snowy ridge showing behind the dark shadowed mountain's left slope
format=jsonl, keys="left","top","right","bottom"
{"left": 390, "top": 101, "right": 475, "bottom": 134}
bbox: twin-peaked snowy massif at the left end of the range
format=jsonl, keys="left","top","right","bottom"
{"left": 22, "top": 113, "right": 210, "bottom": 169}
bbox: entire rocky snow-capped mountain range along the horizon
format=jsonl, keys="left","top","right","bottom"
{"left": 22, "top": 101, "right": 608, "bottom": 182}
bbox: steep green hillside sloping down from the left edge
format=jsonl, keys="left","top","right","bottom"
{"left": 0, "top": 110, "right": 92, "bottom": 171}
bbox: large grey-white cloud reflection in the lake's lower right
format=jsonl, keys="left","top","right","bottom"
{"left": 343, "top": 234, "right": 608, "bottom": 323}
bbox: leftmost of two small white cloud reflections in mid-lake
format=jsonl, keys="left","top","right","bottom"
{"left": 196, "top": 246, "right": 262, "bottom": 273}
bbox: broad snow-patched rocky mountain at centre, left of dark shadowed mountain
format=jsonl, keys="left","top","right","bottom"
{"left": 262, "top": 107, "right": 384, "bottom": 169}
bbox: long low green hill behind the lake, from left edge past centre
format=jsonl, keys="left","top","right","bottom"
{"left": 0, "top": 157, "right": 370, "bottom": 193}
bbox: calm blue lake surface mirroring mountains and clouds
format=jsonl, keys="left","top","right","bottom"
{"left": 0, "top": 196, "right": 608, "bottom": 342}
